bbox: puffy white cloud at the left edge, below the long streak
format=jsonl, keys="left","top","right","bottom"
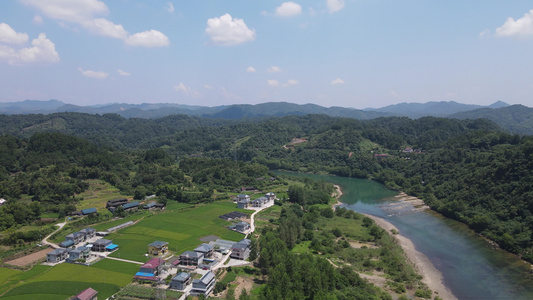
{"left": 0, "top": 33, "right": 59, "bottom": 65}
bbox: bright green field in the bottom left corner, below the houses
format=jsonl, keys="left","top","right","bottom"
{"left": 2, "top": 263, "right": 133, "bottom": 300}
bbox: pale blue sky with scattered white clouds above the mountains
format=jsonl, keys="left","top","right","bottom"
{"left": 0, "top": 0, "right": 533, "bottom": 108}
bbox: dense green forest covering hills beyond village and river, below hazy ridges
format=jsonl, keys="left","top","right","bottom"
{"left": 0, "top": 113, "right": 533, "bottom": 262}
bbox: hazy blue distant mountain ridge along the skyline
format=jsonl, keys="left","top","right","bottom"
{"left": 0, "top": 100, "right": 533, "bottom": 134}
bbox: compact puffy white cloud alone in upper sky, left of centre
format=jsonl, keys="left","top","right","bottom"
{"left": 205, "top": 14, "right": 255, "bottom": 46}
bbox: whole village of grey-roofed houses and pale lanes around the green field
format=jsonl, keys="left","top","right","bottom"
{"left": 44, "top": 192, "right": 276, "bottom": 300}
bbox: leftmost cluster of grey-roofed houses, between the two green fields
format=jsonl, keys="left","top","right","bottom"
{"left": 46, "top": 228, "right": 118, "bottom": 263}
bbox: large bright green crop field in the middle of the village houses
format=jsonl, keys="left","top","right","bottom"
{"left": 108, "top": 202, "right": 251, "bottom": 262}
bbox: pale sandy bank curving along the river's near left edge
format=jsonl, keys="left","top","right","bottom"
{"left": 364, "top": 214, "right": 457, "bottom": 300}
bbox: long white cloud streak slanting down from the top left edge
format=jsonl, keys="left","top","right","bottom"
{"left": 20, "top": 0, "right": 169, "bottom": 47}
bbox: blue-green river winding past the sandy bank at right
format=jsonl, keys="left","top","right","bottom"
{"left": 284, "top": 173, "right": 533, "bottom": 299}
